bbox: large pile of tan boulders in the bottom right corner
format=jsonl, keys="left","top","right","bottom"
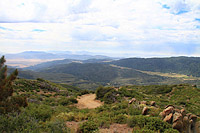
{"left": 160, "top": 105, "right": 198, "bottom": 133}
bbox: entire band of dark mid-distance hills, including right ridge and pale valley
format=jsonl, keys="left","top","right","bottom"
{"left": 9, "top": 57, "right": 200, "bottom": 89}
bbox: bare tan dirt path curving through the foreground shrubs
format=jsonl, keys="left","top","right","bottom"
{"left": 77, "top": 94, "right": 103, "bottom": 109}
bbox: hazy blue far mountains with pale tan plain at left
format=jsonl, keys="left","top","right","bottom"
{"left": 5, "top": 51, "right": 113, "bottom": 68}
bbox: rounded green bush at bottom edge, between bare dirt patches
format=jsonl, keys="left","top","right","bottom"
{"left": 78, "top": 121, "right": 98, "bottom": 133}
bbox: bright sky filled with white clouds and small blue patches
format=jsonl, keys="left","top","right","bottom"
{"left": 0, "top": 0, "right": 200, "bottom": 57}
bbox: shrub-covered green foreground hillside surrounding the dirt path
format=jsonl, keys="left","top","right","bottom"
{"left": 0, "top": 79, "right": 200, "bottom": 133}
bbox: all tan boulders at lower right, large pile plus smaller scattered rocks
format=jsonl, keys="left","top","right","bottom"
{"left": 129, "top": 98, "right": 200, "bottom": 133}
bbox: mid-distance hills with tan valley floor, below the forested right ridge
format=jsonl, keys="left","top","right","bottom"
{"left": 10, "top": 60, "right": 199, "bottom": 89}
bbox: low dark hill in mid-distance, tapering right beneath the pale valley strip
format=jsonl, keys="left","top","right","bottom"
{"left": 36, "top": 63, "right": 186, "bottom": 87}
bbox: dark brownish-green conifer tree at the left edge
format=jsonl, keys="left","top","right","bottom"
{"left": 0, "top": 56, "right": 28, "bottom": 114}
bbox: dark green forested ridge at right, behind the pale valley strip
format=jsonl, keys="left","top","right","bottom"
{"left": 111, "top": 57, "right": 200, "bottom": 77}
